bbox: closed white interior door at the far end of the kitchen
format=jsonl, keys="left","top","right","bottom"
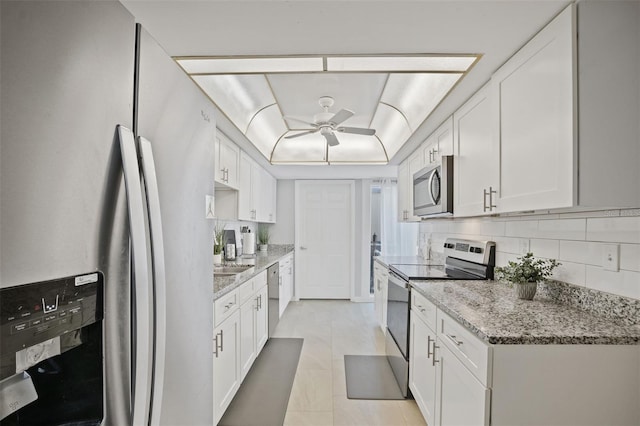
{"left": 295, "top": 181, "right": 355, "bottom": 299}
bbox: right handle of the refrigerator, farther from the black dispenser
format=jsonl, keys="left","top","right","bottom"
{"left": 138, "top": 137, "right": 167, "bottom": 426}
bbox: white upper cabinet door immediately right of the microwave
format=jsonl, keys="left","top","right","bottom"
{"left": 453, "top": 86, "right": 499, "bottom": 216}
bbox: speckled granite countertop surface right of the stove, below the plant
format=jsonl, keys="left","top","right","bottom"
{"left": 410, "top": 281, "right": 640, "bottom": 345}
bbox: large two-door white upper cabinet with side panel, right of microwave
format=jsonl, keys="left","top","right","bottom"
{"left": 450, "top": 1, "right": 640, "bottom": 216}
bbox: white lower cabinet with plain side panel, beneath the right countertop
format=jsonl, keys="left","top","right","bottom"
{"left": 409, "top": 291, "right": 640, "bottom": 426}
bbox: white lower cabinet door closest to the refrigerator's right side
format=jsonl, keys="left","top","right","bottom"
{"left": 213, "top": 309, "right": 240, "bottom": 423}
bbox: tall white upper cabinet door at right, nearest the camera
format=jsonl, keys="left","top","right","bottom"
{"left": 490, "top": 1, "right": 577, "bottom": 212}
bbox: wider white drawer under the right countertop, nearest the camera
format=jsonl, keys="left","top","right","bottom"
{"left": 438, "top": 311, "right": 491, "bottom": 387}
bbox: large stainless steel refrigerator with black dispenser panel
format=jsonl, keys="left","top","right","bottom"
{"left": 0, "top": 1, "right": 215, "bottom": 425}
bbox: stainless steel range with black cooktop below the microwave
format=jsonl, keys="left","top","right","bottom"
{"left": 386, "top": 238, "right": 495, "bottom": 397}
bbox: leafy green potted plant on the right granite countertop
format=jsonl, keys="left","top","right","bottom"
{"left": 495, "top": 252, "right": 561, "bottom": 300}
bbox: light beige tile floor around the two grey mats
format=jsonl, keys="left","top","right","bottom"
{"left": 274, "top": 300, "right": 426, "bottom": 426}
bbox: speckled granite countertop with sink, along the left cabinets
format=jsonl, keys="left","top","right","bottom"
{"left": 213, "top": 244, "right": 294, "bottom": 300}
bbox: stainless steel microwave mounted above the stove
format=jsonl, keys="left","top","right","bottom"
{"left": 413, "top": 155, "right": 453, "bottom": 216}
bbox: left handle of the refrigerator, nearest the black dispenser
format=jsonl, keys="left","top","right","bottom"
{"left": 118, "top": 125, "right": 152, "bottom": 426}
